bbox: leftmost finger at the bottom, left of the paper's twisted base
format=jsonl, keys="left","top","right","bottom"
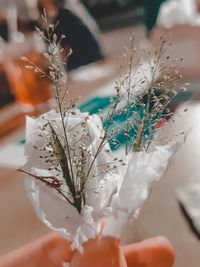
{"left": 0, "top": 233, "right": 72, "bottom": 267}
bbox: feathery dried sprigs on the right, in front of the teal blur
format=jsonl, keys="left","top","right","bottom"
{"left": 105, "top": 37, "right": 188, "bottom": 155}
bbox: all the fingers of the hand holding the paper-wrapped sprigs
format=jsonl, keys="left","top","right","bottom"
{"left": 0, "top": 233, "right": 174, "bottom": 267}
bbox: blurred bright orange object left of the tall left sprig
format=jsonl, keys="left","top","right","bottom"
{"left": 3, "top": 52, "right": 53, "bottom": 110}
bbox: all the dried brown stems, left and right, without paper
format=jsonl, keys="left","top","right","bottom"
{"left": 20, "top": 13, "right": 186, "bottom": 216}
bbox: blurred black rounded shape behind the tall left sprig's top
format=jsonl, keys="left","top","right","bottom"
{"left": 39, "top": 0, "right": 103, "bottom": 70}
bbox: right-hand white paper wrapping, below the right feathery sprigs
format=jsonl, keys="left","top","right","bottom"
{"left": 103, "top": 142, "right": 178, "bottom": 237}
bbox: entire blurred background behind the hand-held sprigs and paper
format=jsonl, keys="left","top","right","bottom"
{"left": 0, "top": 0, "right": 200, "bottom": 267}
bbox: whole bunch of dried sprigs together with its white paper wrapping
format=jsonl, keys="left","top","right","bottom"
{"left": 20, "top": 15, "right": 185, "bottom": 248}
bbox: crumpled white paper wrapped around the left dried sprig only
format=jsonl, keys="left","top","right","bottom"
{"left": 23, "top": 111, "right": 117, "bottom": 248}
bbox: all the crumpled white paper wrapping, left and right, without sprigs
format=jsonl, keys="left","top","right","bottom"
{"left": 23, "top": 108, "right": 180, "bottom": 249}
